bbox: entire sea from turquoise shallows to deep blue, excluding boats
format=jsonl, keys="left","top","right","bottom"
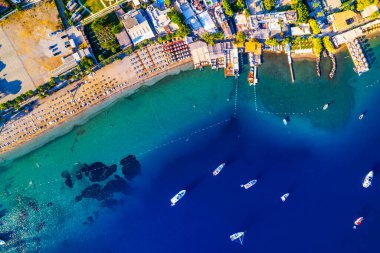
{"left": 0, "top": 40, "right": 380, "bottom": 253}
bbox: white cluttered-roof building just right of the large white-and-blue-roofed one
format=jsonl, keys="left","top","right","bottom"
{"left": 146, "top": 4, "right": 179, "bottom": 35}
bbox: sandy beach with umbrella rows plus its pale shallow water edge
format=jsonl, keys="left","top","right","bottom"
{"left": 0, "top": 53, "right": 192, "bottom": 162}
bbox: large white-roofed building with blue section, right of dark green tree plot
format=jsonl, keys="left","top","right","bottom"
{"left": 120, "top": 9, "right": 155, "bottom": 46}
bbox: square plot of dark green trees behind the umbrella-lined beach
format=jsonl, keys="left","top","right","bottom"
{"left": 84, "top": 13, "right": 123, "bottom": 60}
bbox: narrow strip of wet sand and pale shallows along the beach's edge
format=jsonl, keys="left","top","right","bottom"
{"left": 0, "top": 61, "right": 193, "bottom": 164}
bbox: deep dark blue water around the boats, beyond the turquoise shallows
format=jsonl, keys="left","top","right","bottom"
{"left": 50, "top": 88, "right": 380, "bottom": 253}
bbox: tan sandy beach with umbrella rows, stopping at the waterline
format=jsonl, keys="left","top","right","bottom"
{"left": 0, "top": 51, "right": 192, "bottom": 154}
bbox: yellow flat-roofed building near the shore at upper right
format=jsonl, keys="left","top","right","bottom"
{"left": 329, "top": 10, "right": 362, "bottom": 32}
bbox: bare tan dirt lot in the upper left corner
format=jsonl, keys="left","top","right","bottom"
{"left": 0, "top": 1, "right": 70, "bottom": 87}
